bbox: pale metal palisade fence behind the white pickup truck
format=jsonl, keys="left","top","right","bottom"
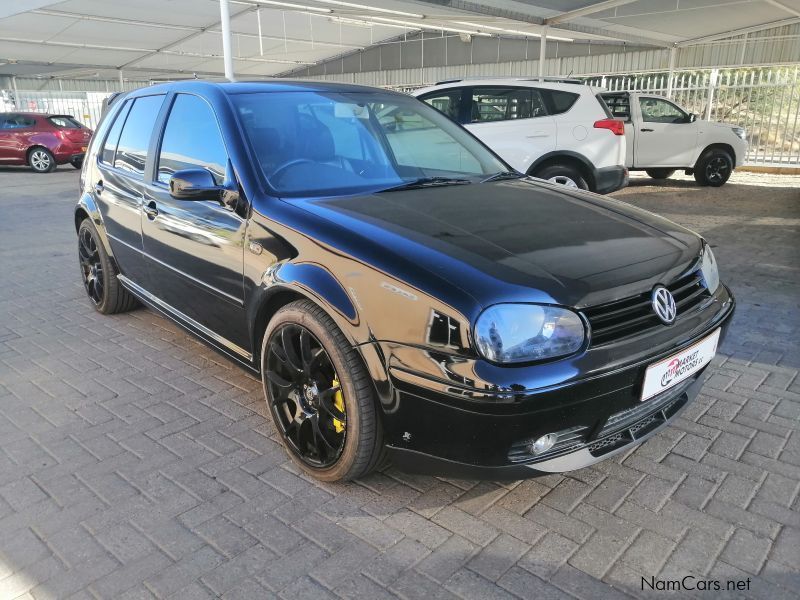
{"left": 585, "top": 65, "right": 800, "bottom": 167}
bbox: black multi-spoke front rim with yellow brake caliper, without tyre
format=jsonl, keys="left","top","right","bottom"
{"left": 264, "top": 323, "right": 347, "bottom": 469}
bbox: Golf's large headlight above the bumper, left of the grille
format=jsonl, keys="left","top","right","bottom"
{"left": 475, "top": 304, "right": 586, "bottom": 363}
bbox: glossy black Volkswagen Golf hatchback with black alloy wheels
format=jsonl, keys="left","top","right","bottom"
{"left": 75, "top": 80, "right": 734, "bottom": 481}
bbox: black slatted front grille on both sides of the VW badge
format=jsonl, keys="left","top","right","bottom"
{"left": 584, "top": 271, "right": 711, "bottom": 346}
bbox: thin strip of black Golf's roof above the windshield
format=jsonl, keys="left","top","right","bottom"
{"left": 126, "top": 79, "right": 406, "bottom": 96}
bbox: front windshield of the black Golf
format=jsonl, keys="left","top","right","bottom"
{"left": 231, "top": 91, "right": 508, "bottom": 197}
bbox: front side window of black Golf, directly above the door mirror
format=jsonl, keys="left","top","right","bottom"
{"left": 158, "top": 94, "right": 228, "bottom": 185}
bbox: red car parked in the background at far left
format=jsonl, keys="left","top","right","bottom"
{"left": 0, "top": 113, "right": 92, "bottom": 173}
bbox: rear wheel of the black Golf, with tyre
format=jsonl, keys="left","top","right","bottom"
{"left": 78, "top": 218, "right": 139, "bottom": 315}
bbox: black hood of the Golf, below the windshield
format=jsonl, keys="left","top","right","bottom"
{"left": 294, "top": 179, "right": 701, "bottom": 307}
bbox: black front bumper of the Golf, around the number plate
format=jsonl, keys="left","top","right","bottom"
{"left": 384, "top": 284, "right": 734, "bottom": 480}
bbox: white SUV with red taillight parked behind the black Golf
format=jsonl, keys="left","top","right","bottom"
{"left": 412, "top": 78, "right": 628, "bottom": 194}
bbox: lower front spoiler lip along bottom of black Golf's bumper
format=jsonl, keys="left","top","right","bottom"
{"left": 388, "top": 374, "right": 705, "bottom": 481}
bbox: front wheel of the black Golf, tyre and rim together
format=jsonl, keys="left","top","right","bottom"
{"left": 261, "top": 300, "right": 386, "bottom": 482}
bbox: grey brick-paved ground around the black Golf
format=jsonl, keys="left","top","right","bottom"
{"left": 0, "top": 168, "right": 800, "bottom": 600}
